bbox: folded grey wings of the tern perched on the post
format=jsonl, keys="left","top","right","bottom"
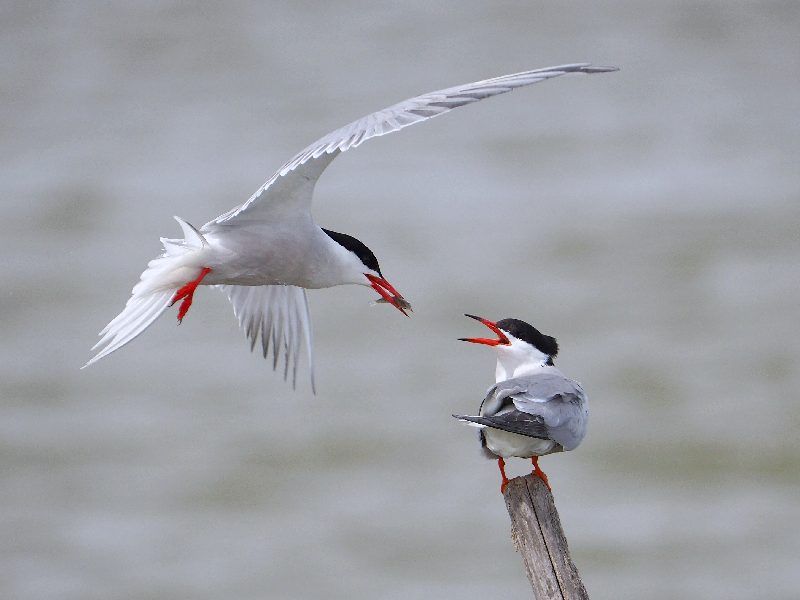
{"left": 453, "top": 373, "right": 589, "bottom": 450}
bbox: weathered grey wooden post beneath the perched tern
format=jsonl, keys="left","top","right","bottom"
{"left": 503, "top": 475, "right": 589, "bottom": 600}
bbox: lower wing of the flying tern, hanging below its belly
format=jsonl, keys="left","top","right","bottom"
{"left": 222, "top": 285, "right": 316, "bottom": 393}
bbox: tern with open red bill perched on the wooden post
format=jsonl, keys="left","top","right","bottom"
{"left": 453, "top": 315, "right": 589, "bottom": 492}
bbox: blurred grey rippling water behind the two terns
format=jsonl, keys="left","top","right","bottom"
{"left": 0, "top": 0, "right": 800, "bottom": 600}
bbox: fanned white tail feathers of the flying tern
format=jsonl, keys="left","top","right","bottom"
{"left": 81, "top": 217, "right": 208, "bottom": 369}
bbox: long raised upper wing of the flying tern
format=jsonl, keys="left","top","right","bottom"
{"left": 203, "top": 63, "right": 617, "bottom": 229}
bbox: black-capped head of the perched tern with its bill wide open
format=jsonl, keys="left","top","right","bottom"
{"left": 460, "top": 315, "right": 558, "bottom": 381}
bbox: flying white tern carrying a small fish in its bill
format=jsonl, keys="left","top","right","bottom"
{"left": 84, "top": 63, "right": 617, "bottom": 389}
